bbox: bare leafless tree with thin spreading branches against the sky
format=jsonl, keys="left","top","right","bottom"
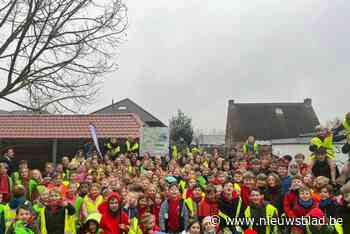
{"left": 0, "top": 0, "right": 127, "bottom": 112}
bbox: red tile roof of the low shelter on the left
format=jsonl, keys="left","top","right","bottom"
{"left": 0, "top": 113, "right": 143, "bottom": 139}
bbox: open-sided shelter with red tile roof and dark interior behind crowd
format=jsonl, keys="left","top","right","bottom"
{"left": 0, "top": 113, "right": 144, "bottom": 168}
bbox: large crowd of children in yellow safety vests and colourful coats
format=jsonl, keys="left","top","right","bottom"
{"left": 0, "top": 115, "right": 350, "bottom": 234}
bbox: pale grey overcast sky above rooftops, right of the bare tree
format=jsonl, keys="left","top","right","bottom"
{"left": 0, "top": 0, "right": 350, "bottom": 129}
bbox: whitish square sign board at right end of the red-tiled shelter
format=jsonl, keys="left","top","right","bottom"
{"left": 140, "top": 127, "right": 169, "bottom": 156}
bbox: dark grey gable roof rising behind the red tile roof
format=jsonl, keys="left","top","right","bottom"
{"left": 91, "top": 98, "right": 166, "bottom": 127}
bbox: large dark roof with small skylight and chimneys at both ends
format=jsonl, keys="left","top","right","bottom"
{"left": 226, "top": 99, "right": 320, "bottom": 144}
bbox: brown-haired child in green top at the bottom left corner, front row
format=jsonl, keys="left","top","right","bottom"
{"left": 6, "top": 204, "right": 39, "bottom": 234}
